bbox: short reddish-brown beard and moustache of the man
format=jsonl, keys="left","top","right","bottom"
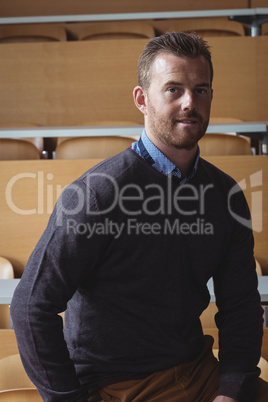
{"left": 147, "top": 102, "right": 209, "bottom": 150}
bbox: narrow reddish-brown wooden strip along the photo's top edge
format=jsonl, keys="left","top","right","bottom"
{"left": 0, "top": 0, "right": 248, "bottom": 17}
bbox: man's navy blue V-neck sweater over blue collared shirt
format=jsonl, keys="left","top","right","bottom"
{"left": 11, "top": 149, "right": 263, "bottom": 402}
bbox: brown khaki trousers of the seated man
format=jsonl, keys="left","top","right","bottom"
{"left": 89, "top": 335, "right": 268, "bottom": 402}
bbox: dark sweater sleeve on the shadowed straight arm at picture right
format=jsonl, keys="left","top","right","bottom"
{"left": 214, "top": 185, "right": 263, "bottom": 402}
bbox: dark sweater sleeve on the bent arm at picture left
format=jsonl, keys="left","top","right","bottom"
{"left": 11, "top": 184, "right": 107, "bottom": 402}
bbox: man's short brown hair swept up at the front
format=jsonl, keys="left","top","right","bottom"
{"left": 138, "top": 32, "right": 213, "bottom": 89}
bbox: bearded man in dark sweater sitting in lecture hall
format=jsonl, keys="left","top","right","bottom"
{"left": 11, "top": 33, "right": 268, "bottom": 402}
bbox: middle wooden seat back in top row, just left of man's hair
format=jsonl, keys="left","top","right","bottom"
{"left": 78, "top": 21, "right": 155, "bottom": 40}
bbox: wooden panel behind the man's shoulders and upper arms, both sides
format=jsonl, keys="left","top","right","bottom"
{"left": 0, "top": 156, "right": 268, "bottom": 277}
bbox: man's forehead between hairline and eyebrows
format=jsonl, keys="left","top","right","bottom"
{"left": 152, "top": 52, "right": 210, "bottom": 83}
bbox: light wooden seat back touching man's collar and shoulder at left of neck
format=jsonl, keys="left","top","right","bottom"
{"left": 55, "top": 136, "right": 134, "bottom": 159}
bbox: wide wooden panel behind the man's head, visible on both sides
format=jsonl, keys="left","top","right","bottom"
{"left": 0, "top": 36, "right": 268, "bottom": 126}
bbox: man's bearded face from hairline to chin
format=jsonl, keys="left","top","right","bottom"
{"left": 141, "top": 53, "right": 212, "bottom": 150}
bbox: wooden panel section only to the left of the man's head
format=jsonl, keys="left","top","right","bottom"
{"left": 0, "top": 39, "right": 147, "bottom": 126}
